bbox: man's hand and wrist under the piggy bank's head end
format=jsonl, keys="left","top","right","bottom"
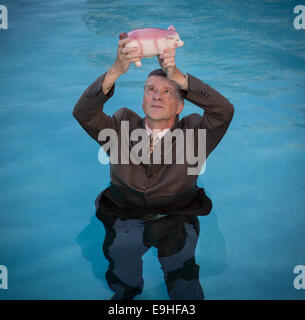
{"left": 158, "top": 48, "right": 187, "bottom": 90}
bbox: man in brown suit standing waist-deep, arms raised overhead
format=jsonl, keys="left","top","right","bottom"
{"left": 73, "top": 38, "right": 234, "bottom": 299}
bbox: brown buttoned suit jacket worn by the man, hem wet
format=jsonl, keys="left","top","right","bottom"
{"left": 73, "top": 74, "right": 234, "bottom": 217}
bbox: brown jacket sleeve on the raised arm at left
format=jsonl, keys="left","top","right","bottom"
{"left": 72, "top": 73, "right": 119, "bottom": 141}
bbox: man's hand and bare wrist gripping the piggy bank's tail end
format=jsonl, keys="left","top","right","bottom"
{"left": 102, "top": 38, "right": 143, "bottom": 94}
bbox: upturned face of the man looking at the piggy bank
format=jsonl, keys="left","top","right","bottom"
{"left": 142, "top": 76, "right": 184, "bottom": 127}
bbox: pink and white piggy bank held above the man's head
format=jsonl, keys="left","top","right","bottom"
{"left": 120, "top": 26, "right": 183, "bottom": 67}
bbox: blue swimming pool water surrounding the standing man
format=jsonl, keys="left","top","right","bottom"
{"left": 0, "top": 0, "right": 305, "bottom": 299}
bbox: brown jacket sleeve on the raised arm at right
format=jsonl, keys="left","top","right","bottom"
{"left": 184, "top": 74, "right": 234, "bottom": 157}
